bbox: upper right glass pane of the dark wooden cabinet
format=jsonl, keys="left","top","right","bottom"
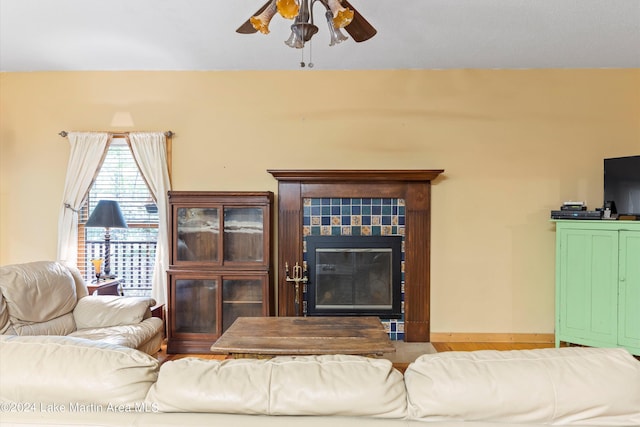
{"left": 223, "top": 207, "right": 264, "bottom": 262}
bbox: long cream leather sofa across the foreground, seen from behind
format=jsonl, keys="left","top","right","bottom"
{"left": 0, "top": 336, "right": 640, "bottom": 427}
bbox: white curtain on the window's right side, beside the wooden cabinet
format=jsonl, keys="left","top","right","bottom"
{"left": 129, "top": 132, "right": 171, "bottom": 304}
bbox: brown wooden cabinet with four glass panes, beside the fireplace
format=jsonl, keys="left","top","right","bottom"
{"left": 167, "top": 191, "right": 274, "bottom": 353}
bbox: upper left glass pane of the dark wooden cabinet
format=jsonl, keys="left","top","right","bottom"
{"left": 174, "top": 207, "right": 220, "bottom": 263}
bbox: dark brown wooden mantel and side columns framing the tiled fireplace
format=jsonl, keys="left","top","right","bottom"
{"left": 268, "top": 169, "right": 444, "bottom": 342}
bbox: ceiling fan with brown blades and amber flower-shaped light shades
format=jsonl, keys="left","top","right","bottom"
{"left": 236, "top": 0, "right": 377, "bottom": 49}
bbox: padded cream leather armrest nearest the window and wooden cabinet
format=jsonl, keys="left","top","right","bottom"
{"left": 73, "top": 295, "right": 156, "bottom": 329}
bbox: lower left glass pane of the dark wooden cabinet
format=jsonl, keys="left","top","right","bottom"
{"left": 173, "top": 278, "right": 218, "bottom": 335}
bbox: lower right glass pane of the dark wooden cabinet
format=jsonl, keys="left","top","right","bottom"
{"left": 222, "top": 276, "right": 266, "bottom": 332}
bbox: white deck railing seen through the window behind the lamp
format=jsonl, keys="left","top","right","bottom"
{"left": 81, "top": 240, "right": 156, "bottom": 296}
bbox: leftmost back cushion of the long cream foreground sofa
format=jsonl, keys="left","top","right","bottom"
{"left": 0, "top": 335, "right": 159, "bottom": 411}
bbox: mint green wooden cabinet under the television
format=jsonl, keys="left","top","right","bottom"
{"left": 555, "top": 220, "right": 640, "bottom": 355}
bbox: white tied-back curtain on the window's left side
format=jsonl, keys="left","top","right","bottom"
{"left": 58, "top": 132, "right": 109, "bottom": 266}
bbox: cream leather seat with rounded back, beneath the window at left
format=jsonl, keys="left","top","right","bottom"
{"left": 0, "top": 261, "right": 164, "bottom": 354}
